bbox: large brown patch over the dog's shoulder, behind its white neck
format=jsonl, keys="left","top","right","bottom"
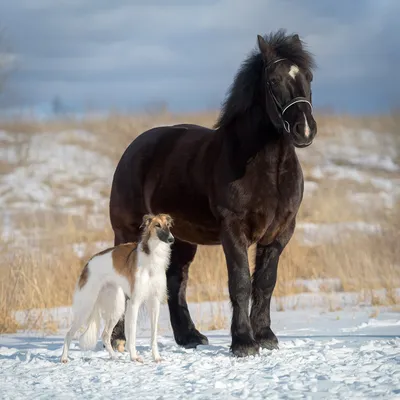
{"left": 111, "top": 242, "right": 138, "bottom": 291}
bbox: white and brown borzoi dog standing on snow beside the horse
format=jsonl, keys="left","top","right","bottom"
{"left": 61, "top": 214, "right": 174, "bottom": 363}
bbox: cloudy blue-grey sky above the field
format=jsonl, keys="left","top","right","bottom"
{"left": 0, "top": 0, "right": 400, "bottom": 113}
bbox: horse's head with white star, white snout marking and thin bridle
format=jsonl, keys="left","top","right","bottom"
{"left": 258, "top": 35, "right": 317, "bottom": 147}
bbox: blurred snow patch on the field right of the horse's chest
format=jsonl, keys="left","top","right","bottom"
{"left": 298, "top": 126, "right": 400, "bottom": 209}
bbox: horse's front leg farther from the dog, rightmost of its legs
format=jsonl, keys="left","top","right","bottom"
{"left": 250, "top": 223, "right": 294, "bottom": 350}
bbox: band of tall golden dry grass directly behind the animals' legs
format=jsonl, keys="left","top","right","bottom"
{"left": 0, "top": 212, "right": 400, "bottom": 333}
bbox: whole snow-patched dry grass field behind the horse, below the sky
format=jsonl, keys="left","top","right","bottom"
{"left": 0, "top": 112, "right": 400, "bottom": 333}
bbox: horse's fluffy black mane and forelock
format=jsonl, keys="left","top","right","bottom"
{"left": 214, "top": 29, "right": 315, "bottom": 128}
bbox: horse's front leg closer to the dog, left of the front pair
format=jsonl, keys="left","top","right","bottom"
{"left": 221, "top": 222, "right": 259, "bottom": 357}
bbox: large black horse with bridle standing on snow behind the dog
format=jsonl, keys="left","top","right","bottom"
{"left": 110, "top": 30, "right": 317, "bottom": 356}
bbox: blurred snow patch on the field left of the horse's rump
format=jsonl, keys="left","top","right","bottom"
{"left": 0, "top": 131, "right": 115, "bottom": 213}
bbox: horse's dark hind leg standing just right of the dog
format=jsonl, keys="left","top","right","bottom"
{"left": 167, "top": 239, "right": 208, "bottom": 348}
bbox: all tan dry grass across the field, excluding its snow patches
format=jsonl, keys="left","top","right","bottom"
{"left": 0, "top": 113, "right": 400, "bottom": 333}
